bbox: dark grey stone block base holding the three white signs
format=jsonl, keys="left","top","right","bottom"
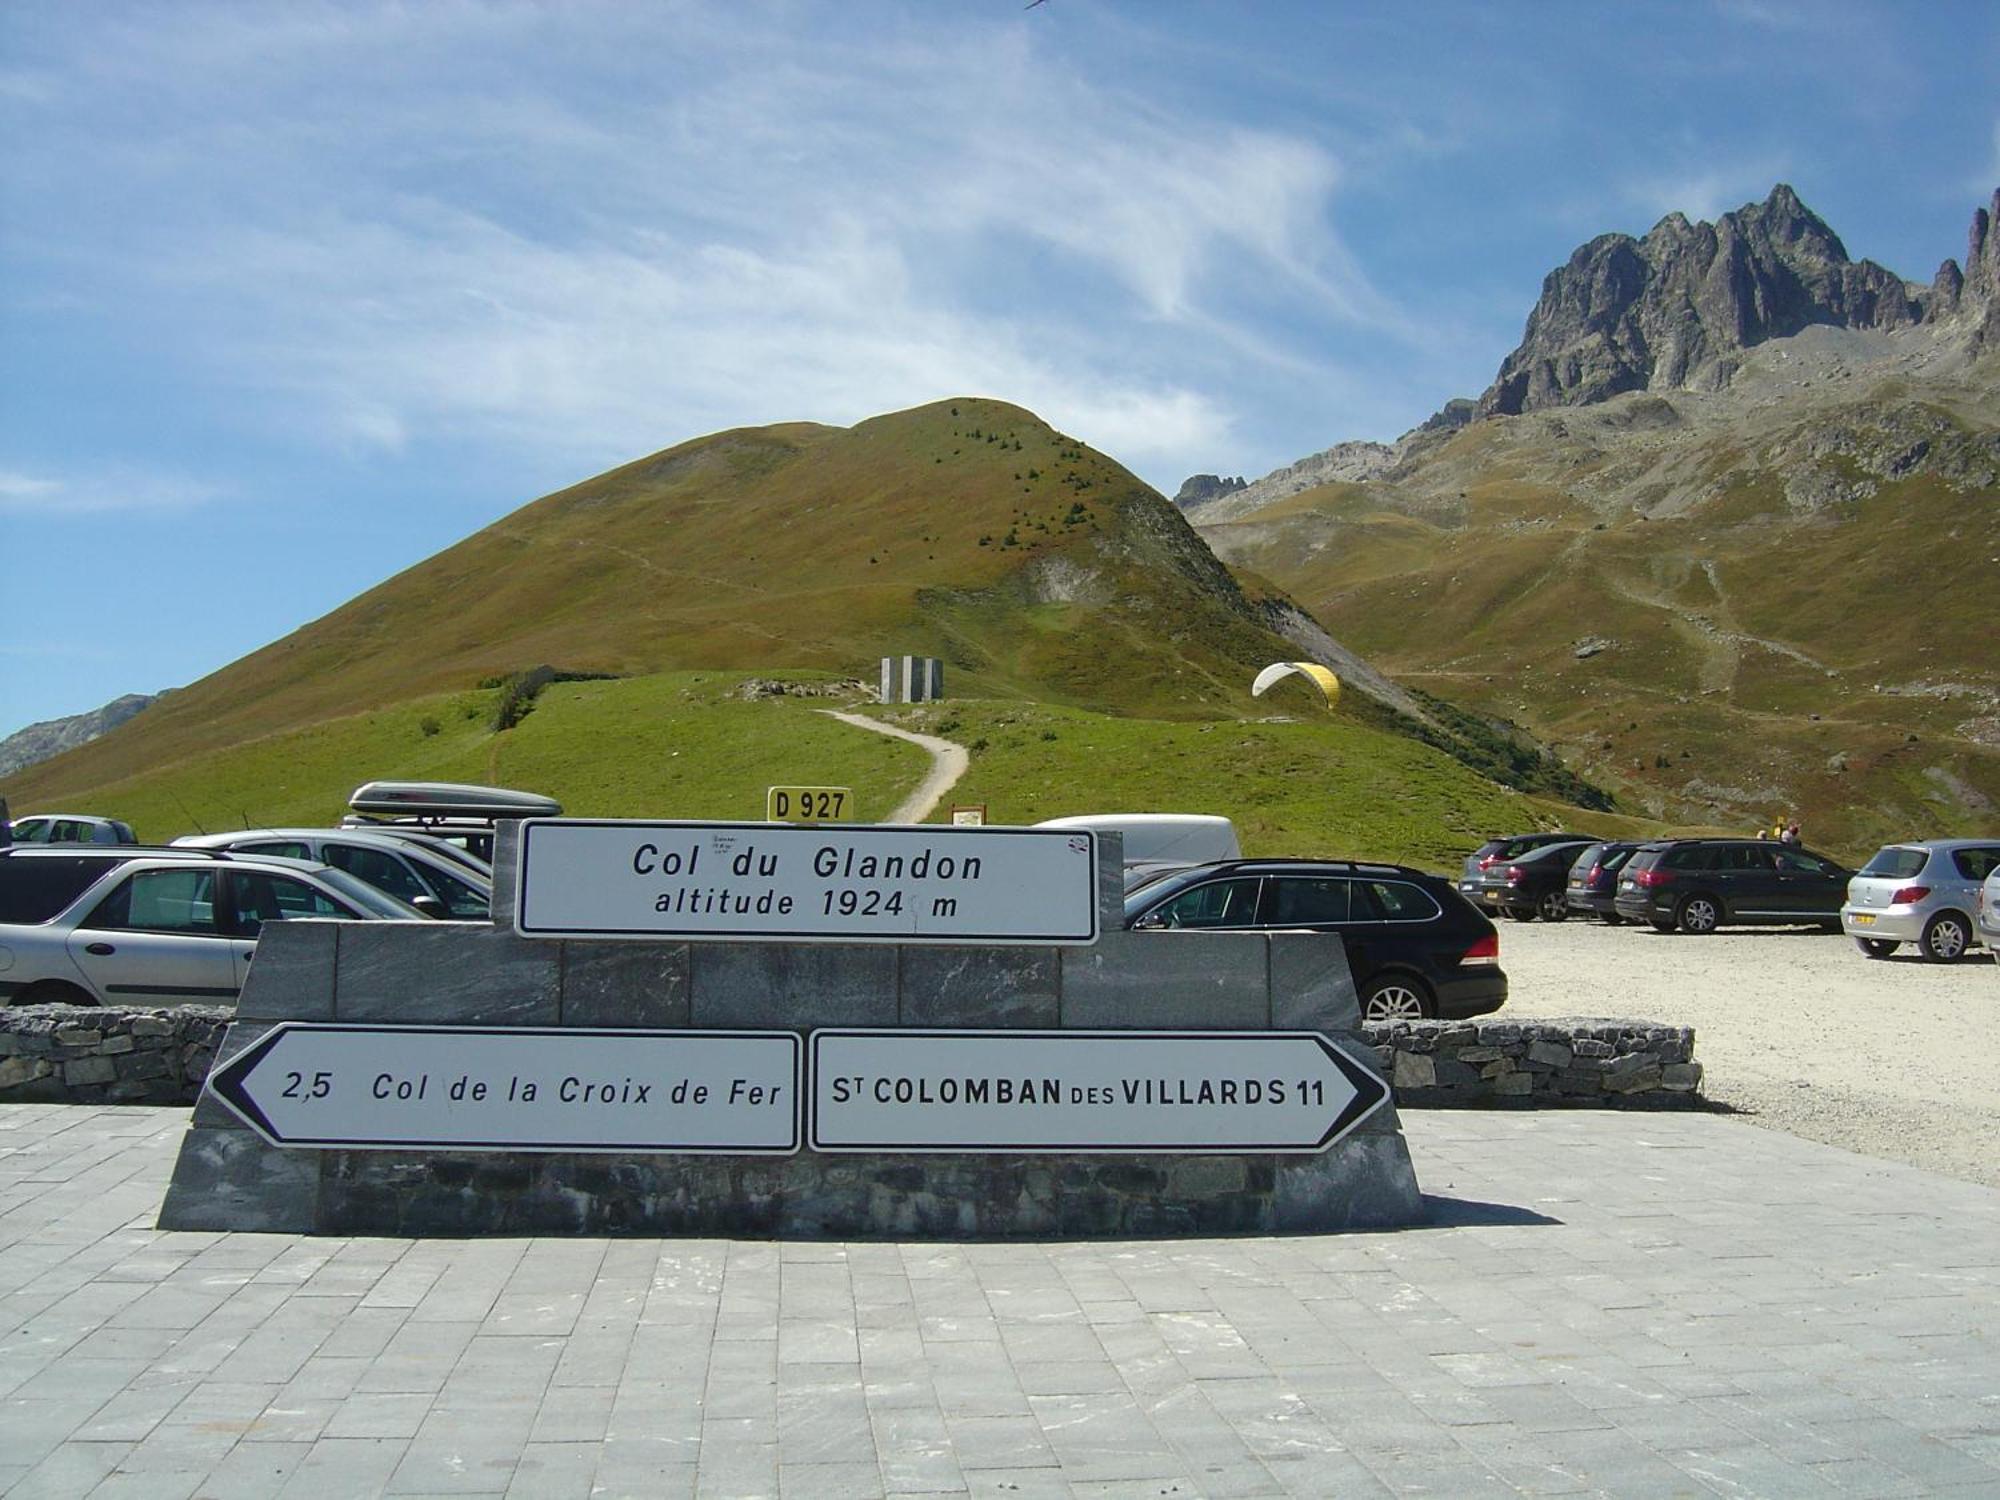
{"left": 160, "top": 848, "right": 1424, "bottom": 1238}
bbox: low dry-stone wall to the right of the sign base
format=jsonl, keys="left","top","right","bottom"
{"left": 1364, "top": 1016, "right": 1702, "bottom": 1110}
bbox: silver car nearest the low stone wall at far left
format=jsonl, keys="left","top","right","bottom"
{"left": 0, "top": 846, "right": 424, "bottom": 1006}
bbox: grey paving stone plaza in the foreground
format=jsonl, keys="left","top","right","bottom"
{"left": 0, "top": 1106, "right": 2000, "bottom": 1500}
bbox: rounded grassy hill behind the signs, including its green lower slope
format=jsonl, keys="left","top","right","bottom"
{"left": 0, "top": 400, "right": 1640, "bottom": 862}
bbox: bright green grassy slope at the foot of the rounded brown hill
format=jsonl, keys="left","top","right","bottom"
{"left": 11, "top": 672, "right": 1648, "bottom": 868}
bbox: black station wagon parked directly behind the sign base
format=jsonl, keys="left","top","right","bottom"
{"left": 1124, "top": 860, "right": 1506, "bottom": 1020}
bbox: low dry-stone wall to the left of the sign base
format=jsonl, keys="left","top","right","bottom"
{"left": 0, "top": 1006, "right": 230, "bottom": 1104}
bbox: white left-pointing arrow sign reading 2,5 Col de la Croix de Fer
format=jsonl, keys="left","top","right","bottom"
{"left": 208, "top": 1022, "right": 800, "bottom": 1154}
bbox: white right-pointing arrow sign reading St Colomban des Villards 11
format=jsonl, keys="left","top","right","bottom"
{"left": 808, "top": 1030, "right": 1388, "bottom": 1152}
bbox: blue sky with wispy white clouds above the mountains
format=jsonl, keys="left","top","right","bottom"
{"left": 0, "top": 0, "right": 2000, "bottom": 734}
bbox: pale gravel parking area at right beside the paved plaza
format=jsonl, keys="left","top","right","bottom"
{"left": 1498, "top": 918, "right": 2000, "bottom": 1188}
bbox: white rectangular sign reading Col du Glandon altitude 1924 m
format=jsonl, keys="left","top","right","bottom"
{"left": 514, "top": 818, "right": 1098, "bottom": 944}
